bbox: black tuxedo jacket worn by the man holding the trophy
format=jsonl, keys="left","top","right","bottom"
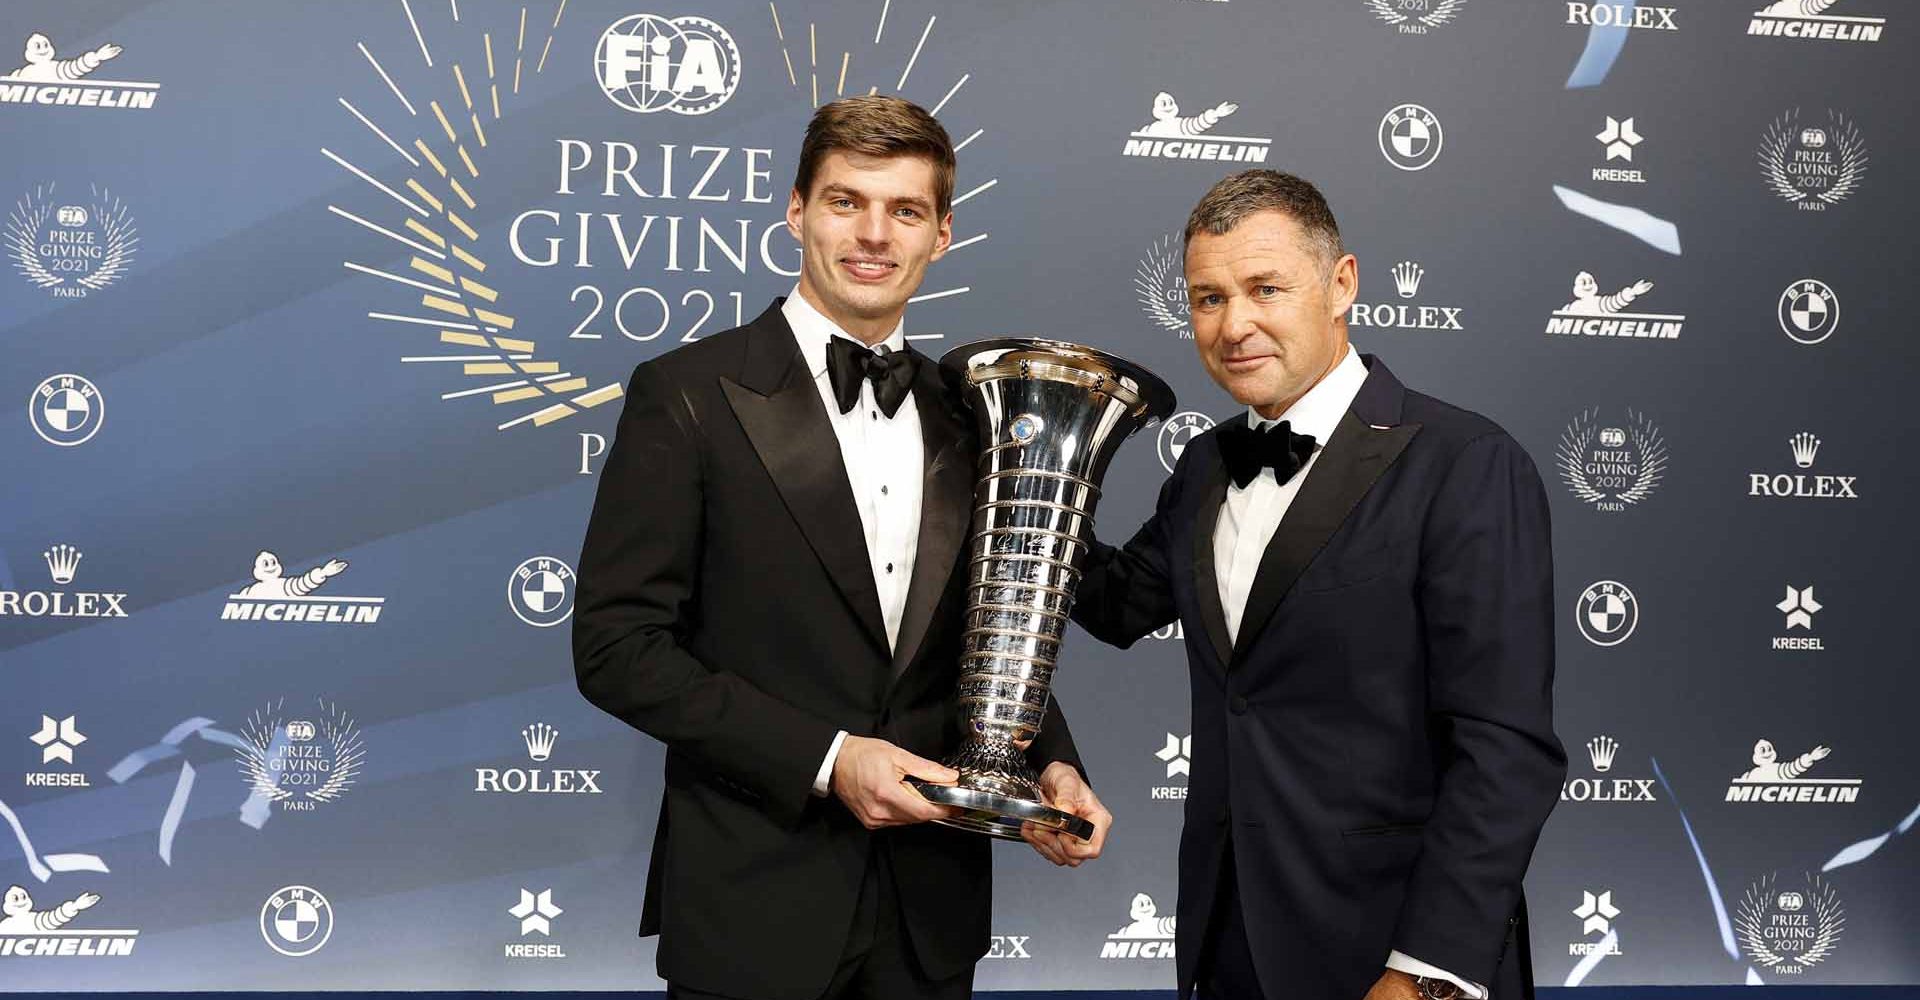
{"left": 574, "top": 299, "right": 1079, "bottom": 1000}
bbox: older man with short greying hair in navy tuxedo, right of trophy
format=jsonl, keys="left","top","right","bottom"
{"left": 1073, "top": 171, "right": 1567, "bottom": 1000}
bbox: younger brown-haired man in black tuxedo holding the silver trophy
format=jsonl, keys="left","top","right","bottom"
{"left": 574, "top": 96, "right": 1112, "bottom": 1000}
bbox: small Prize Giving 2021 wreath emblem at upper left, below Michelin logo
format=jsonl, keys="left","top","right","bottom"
{"left": 6, "top": 184, "right": 140, "bottom": 299}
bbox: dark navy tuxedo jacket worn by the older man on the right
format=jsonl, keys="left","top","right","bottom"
{"left": 1073, "top": 357, "right": 1567, "bottom": 1000}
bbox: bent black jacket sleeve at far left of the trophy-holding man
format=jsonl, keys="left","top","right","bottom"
{"left": 572, "top": 365, "right": 839, "bottom": 823}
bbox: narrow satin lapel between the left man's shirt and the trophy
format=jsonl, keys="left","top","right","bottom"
{"left": 889, "top": 357, "right": 973, "bottom": 683}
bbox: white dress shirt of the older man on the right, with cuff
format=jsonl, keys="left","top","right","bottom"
{"left": 1213, "top": 345, "right": 1486, "bottom": 1000}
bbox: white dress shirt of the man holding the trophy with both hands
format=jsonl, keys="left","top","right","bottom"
{"left": 780, "top": 286, "right": 927, "bottom": 797}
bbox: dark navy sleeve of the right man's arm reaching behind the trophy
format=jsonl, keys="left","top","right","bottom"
{"left": 1073, "top": 462, "right": 1192, "bottom": 649}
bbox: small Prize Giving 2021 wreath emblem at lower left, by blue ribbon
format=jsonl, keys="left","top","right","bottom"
{"left": 236, "top": 699, "right": 367, "bottom": 812}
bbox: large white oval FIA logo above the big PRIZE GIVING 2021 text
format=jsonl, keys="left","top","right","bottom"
{"left": 593, "top": 13, "right": 739, "bottom": 115}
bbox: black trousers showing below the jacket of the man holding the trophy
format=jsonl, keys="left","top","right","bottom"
{"left": 666, "top": 839, "right": 973, "bottom": 1000}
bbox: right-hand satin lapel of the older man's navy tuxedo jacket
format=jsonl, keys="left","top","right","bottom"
{"left": 1235, "top": 413, "right": 1421, "bottom": 660}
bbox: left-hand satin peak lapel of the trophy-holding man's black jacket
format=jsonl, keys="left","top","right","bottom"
{"left": 720, "top": 314, "right": 887, "bottom": 653}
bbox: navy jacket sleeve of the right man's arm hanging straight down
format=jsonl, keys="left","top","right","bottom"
{"left": 1394, "top": 432, "right": 1567, "bottom": 983}
